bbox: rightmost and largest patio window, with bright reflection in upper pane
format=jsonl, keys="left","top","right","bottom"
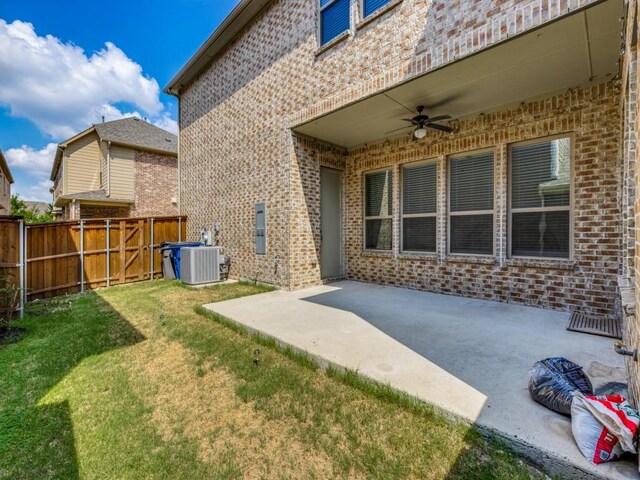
{"left": 510, "top": 138, "right": 571, "bottom": 258}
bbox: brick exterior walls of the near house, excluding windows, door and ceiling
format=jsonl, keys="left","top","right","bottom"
{"left": 179, "top": 0, "right": 640, "bottom": 410}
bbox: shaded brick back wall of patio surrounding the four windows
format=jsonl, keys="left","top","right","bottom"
{"left": 346, "top": 82, "right": 621, "bottom": 316}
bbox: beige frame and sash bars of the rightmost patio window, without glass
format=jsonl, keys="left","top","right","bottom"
{"left": 507, "top": 132, "right": 576, "bottom": 262}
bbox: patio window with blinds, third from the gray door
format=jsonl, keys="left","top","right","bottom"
{"left": 449, "top": 152, "right": 493, "bottom": 255}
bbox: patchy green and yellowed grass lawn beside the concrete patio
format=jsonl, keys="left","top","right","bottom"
{"left": 0, "top": 281, "right": 535, "bottom": 480}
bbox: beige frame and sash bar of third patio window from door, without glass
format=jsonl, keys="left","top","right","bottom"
{"left": 446, "top": 146, "right": 499, "bottom": 258}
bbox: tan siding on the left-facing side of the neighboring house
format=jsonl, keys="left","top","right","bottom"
{"left": 63, "top": 133, "right": 100, "bottom": 195}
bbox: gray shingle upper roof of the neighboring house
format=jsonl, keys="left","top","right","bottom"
{"left": 94, "top": 117, "right": 178, "bottom": 154}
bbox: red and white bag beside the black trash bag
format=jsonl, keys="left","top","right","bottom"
{"left": 571, "top": 392, "right": 640, "bottom": 464}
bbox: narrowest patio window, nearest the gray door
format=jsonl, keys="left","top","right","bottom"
{"left": 364, "top": 170, "right": 393, "bottom": 250}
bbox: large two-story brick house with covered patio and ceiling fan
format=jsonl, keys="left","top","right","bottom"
{"left": 165, "top": 0, "right": 640, "bottom": 400}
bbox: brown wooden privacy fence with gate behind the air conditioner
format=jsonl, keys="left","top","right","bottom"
{"left": 0, "top": 216, "right": 186, "bottom": 307}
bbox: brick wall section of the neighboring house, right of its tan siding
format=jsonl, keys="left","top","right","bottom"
{"left": 131, "top": 151, "right": 178, "bottom": 217}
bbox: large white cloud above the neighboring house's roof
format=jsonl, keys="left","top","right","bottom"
{"left": 0, "top": 19, "right": 175, "bottom": 140}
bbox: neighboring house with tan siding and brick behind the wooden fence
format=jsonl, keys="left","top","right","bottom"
{"left": 51, "top": 117, "right": 178, "bottom": 220}
